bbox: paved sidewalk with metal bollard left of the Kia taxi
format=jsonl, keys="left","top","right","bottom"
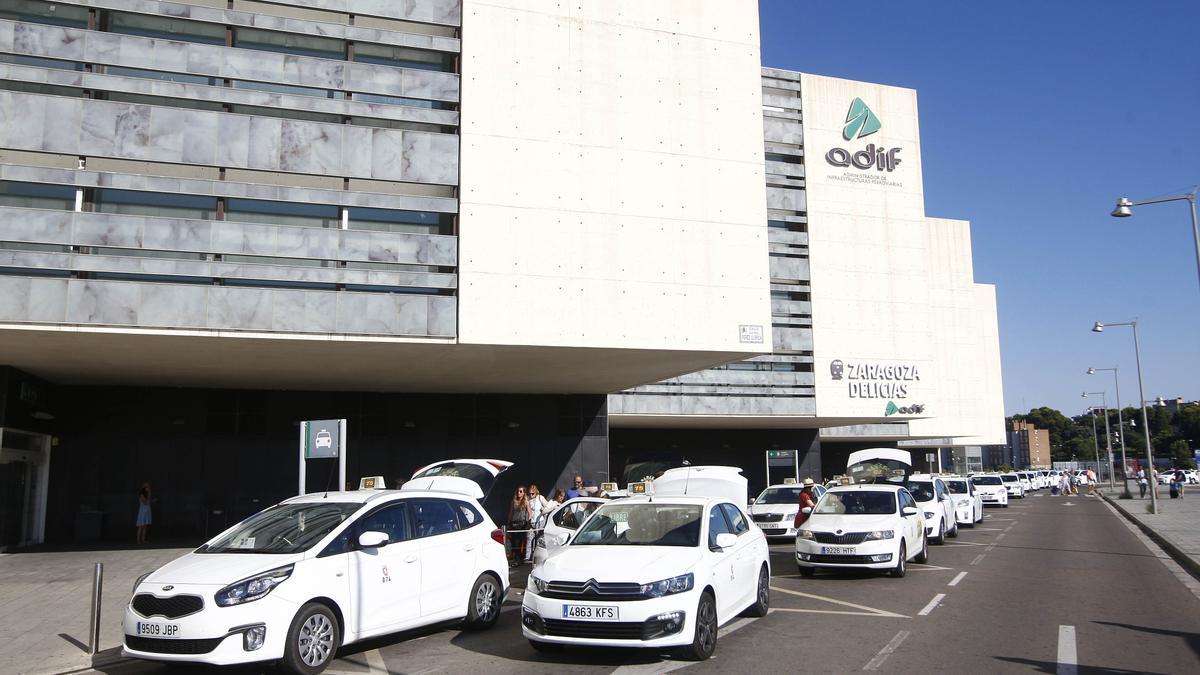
{"left": 0, "top": 540, "right": 190, "bottom": 674}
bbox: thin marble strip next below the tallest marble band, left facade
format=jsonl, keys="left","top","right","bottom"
{"left": 0, "top": 162, "right": 458, "bottom": 214}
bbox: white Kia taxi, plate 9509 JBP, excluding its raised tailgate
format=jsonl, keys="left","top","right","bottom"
{"left": 124, "top": 456, "right": 509, "bottom": 675}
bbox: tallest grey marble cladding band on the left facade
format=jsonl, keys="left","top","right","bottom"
{"left": 0, "top": 91, "right": 458, "bottom": 185}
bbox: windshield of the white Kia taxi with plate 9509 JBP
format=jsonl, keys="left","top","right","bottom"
{"left": 196, "top": 502, "right": 362, "bottom": 554}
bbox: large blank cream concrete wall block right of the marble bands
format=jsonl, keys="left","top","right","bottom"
{"left": 460, "top": 0, "right": 772, "bottom": 358}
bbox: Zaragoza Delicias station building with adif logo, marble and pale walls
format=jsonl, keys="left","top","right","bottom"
{"left": 0, "top": 0, "right": 1001, "bottom": 546}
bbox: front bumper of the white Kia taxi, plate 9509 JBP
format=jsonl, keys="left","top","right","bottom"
{"left": 121, "top": 585, "right": 299, "bottom": 665}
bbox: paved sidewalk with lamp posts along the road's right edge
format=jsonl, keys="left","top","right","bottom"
{"left": 1103, "top": 483, "right": 1200, "bottom": 578}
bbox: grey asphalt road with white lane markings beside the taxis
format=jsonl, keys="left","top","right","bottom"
{"left": 84, "top": 491, "right": 1200, "bottom": 675}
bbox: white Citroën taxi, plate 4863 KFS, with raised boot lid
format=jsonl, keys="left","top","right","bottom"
{"left": 521, "top": 466, "right": 770, "bottom": 661}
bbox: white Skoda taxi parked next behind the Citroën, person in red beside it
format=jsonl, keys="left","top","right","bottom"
{"left": 796, "top": 483, "right": 929, "bottom": 577}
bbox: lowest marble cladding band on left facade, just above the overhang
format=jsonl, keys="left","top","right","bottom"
{"left": 0, "top": 276, "right": 455, "bottom": 336}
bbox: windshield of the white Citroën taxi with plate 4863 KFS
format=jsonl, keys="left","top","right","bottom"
{"left": 571, "top": 502, "right": 700, "bottom": 546}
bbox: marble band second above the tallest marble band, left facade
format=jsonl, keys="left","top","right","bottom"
{"left": 0, "top": 22, "right": 460, "bottom": 102}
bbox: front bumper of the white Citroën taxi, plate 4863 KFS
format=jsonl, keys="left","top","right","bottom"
{"left": 521, "top": 589, "right": 701, "bottom": 647}
